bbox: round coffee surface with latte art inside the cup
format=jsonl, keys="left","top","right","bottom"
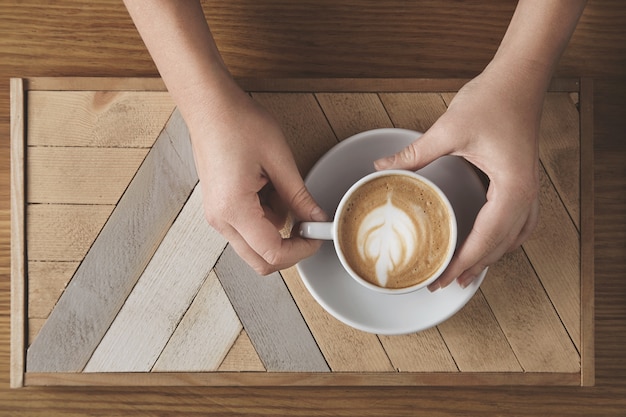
{"left": 338, "top": 175, "right": 450, "bottom": 288}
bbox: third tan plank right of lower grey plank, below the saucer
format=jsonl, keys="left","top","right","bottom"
{"left": 439, "top": 291, "right": 522, "bottom": 372}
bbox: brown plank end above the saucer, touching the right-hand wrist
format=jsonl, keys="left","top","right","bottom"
{"left": 379, "top": 93, "right": 446, "bottom": 132}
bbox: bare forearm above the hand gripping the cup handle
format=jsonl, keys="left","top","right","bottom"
{"left": 124, "top": 0, "right": 240, "bottom": 128}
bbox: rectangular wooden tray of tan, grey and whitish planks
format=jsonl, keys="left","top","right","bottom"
{"left": 11, "top": 78, "right": 594, "bottom": 387}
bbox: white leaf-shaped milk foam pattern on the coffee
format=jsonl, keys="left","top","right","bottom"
{"left": 357, "top": 192, "right": 428, "bottom": 287}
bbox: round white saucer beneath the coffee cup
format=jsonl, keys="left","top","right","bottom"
{"left": 297, "top": 129, "right": 487, "bottom": 335}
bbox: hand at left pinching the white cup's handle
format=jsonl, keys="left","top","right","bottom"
{"left": 190, "top": 83, "right": 327, "bottom": 275}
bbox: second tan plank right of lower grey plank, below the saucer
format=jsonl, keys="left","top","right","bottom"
{"left": 378, "top": 327, "right": 458, "bottom": 372}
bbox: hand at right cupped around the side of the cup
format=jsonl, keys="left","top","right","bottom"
{"left": 376, "top": 68, "right": 543, "bottom": 291}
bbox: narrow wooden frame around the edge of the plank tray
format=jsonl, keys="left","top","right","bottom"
{"left": 10, "top": 78, "right": 595, "bottom": 387}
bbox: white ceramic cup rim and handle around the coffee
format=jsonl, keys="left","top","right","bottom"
{"left": 299, "top": 170, "right": 457, "bottom": 294}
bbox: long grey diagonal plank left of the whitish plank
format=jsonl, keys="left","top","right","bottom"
{"left": 27, "top": 108, "right": 197, "bottom": 372}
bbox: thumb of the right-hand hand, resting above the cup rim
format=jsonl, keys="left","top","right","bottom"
{"left": 374, "top": 128, "right": 453, "bottom": 170}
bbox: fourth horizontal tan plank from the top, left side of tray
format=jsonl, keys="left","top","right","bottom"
{"left": 28, "top": 262, "right": 79, "bottom": 319}
